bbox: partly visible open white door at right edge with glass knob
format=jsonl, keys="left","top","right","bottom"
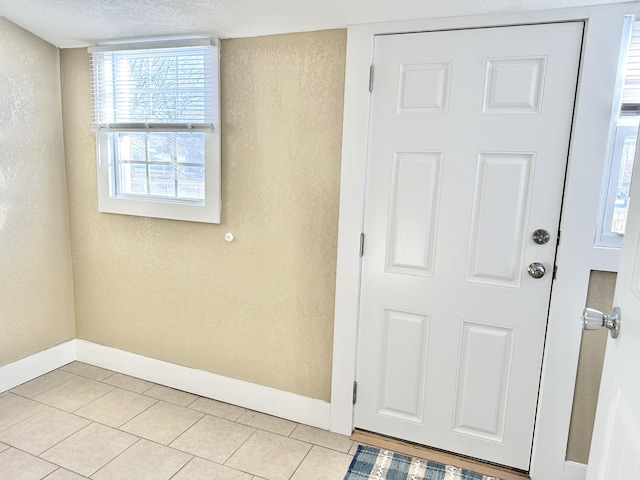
{"left": 587, "top": 143, "right": 640, "bottom": 480}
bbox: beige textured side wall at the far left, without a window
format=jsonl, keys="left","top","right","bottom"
{"left": 0, "top": 17, "right": 75, "bottom": 365}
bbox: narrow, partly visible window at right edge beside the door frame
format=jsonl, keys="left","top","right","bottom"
{"left": 596, "top": 17, "right": 640, "bottom": 248}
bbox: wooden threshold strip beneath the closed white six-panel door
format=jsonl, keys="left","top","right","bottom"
{"left": 351, "top": 430, "right": 531, "bottom": 480}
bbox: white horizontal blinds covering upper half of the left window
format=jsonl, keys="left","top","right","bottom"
{"left": 89, "top": 40, "right": 218, "bottom": 131}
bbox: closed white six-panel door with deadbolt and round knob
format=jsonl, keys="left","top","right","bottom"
{"left": 355, "top": 22, "right": 583, "bottom": 470}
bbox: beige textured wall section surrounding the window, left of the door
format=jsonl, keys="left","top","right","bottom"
{"left": 61, "top": 30, "right": 346, "bottom": 401}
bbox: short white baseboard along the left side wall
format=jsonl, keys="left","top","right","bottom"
{"left": 0, "top": 340, "right": 76, "bottom": 392}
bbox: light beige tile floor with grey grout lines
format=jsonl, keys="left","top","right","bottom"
{"left": 0, "top": 362, "right": 357, "bottom": 480}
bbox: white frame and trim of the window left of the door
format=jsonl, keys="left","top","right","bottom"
{"left": 89, "top": 38, "right": 222, "bottom": 224}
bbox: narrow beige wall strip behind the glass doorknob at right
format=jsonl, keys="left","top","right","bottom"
{"left": 567, "top": 271, "right": 616, "bottom": 464}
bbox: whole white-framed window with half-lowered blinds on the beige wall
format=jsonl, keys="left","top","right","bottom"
{"left": 89, "top": 39, "right": 221, "bottom": 223}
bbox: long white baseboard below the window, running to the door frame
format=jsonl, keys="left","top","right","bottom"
{"left": 76, "top": 340, "right": 331, "bottom": 430}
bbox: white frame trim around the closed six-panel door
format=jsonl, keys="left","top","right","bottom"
{"left": 330, "top": 2, "right": 640, "bottom": 480}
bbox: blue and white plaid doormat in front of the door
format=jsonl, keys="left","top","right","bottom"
{"left": 344, "top": 445, "right": 500, "bottom": 480}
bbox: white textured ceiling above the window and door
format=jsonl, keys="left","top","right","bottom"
{"left": 0, "top": 0, "right": 632, "bottom": 48}
